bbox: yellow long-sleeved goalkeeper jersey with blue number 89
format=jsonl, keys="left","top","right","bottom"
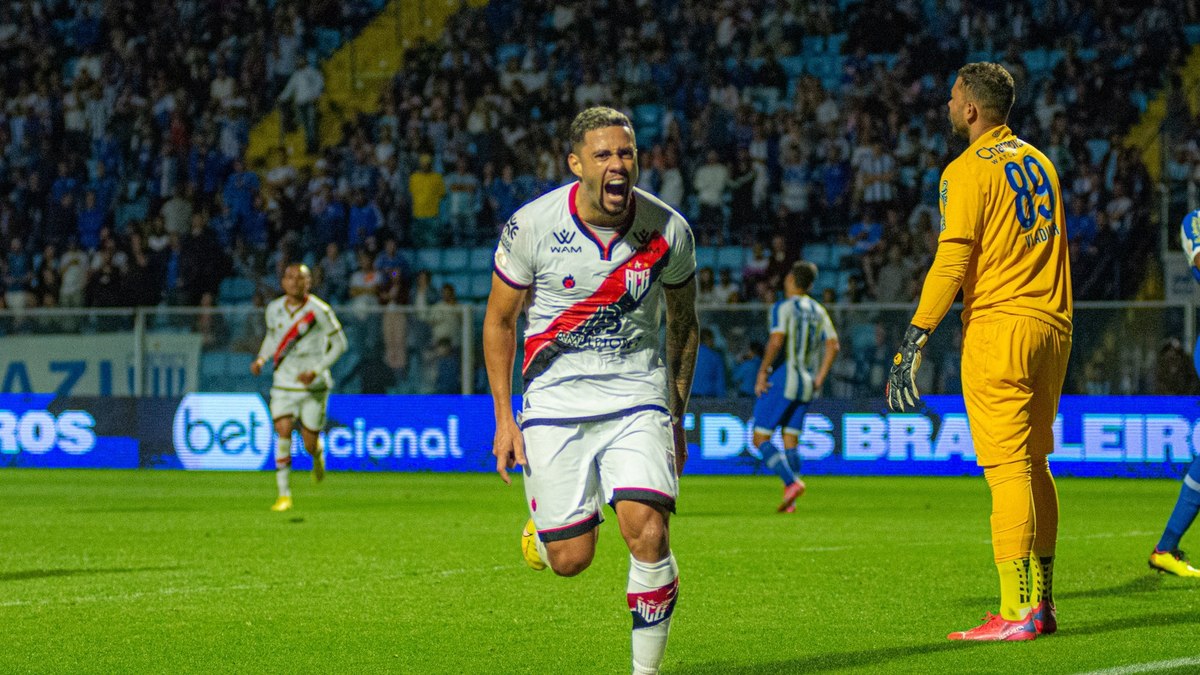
{"left": 913, "top": 126, "right": 1072, "bottom": 333}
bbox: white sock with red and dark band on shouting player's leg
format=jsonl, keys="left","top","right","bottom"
{"left": 625, "top": 552, "right": 679, "bottom": 675}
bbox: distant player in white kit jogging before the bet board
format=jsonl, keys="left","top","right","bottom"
{"left": 250, "top": 263, "right": 347, "bottom": 510}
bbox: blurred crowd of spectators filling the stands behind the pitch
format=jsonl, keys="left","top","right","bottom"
{"left": 0, "top": 0, "right": 1200, "bottom": 393}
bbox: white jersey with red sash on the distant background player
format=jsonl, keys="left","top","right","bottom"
{"left": 258, "top": 295, "right": 346, "bottom": 390}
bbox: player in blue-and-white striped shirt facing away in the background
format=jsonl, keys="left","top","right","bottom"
{"left": 754, "top": 261, "right": 839, "bottom": 513}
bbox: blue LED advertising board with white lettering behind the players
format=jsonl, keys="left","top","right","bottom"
{"left": 0, "top": 393, "right": 1200, "bottom": 477}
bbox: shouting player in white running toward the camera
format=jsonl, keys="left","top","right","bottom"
{"left": 484, "top": 107, "right": 698, "bottom": 673}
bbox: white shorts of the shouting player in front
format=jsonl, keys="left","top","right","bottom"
{"left": 521, "top": 406, "right": 679, "bottom": 542}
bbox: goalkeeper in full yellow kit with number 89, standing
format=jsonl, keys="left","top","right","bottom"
{"left": 887, "top": 62, "right": 1072, "bottom": 640}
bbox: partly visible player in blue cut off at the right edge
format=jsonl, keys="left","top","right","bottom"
{"left": 1150, "top": 211, "right": 1200, "bottom": 579}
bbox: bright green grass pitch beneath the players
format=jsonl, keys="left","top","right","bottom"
{"left": 0, "top": 470, "right": 1200, "bottom": 674}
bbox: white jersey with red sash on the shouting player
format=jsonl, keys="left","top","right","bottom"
{"left": 494, "top": 183, "right": 696, "bottom": 424}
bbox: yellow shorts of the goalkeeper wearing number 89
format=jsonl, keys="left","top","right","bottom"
{"left": 962, "top": 313, "right": 1070, "bottom": 466}
